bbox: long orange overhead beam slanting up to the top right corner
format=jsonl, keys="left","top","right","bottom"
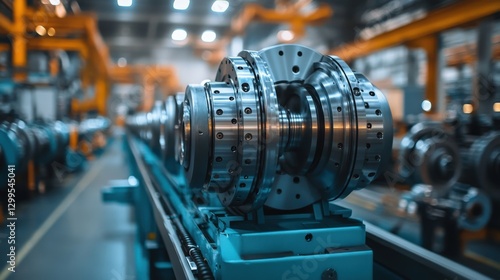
{"left": 329, "top": 0, "right": 500, "bottom": 60}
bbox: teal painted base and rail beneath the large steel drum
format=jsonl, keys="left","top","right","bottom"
{"left": 115, "top": 135, "right": 373, "bottom": 280}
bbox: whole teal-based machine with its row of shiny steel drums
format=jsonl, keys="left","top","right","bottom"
{"left": 103, "top": 45, "right": 488, "bottom": 279}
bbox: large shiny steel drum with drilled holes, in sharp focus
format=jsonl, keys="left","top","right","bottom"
{"left": 180, "top": 45, "right": 392, "bottom": 212}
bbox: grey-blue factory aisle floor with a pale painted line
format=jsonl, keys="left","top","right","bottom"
{"left": 0, "top": 134, "right": 136, "bottom": 280}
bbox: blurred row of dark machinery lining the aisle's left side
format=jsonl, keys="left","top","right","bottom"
{"left": 0, "top": 118, "right": 111, "bottom": 196}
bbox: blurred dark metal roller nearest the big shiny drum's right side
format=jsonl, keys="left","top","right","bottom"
{"left": 399, "top": 122, "right": 462, "bottom": 197}
